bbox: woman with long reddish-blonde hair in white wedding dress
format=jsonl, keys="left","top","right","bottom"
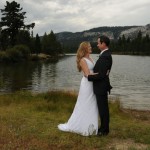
{"left": 58, "top": 42, "right": 98, "bottom": 136}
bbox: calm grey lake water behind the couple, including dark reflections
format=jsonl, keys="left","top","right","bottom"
{"left": 0, "top": 54, "right": 150, "bottom": 110}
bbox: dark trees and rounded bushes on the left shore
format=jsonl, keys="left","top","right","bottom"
{"left": 0, "top": 1, "right": 63, "bottom": 62}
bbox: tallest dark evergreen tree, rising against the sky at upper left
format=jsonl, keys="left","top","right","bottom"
{"left": 0, "top": 1, "right": 35, "bottom": 46}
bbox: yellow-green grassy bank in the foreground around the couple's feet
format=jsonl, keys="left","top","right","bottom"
{"left": 0, "top": 92, "right": 150, "bottom": 150}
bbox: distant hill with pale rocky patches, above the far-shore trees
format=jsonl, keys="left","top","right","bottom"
{"left": 55, "top": 24, "right": 150, "bottom": 51}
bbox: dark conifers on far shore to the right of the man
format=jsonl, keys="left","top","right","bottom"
{"left": 110, "top": 31, "right": 150, "bottom": 55}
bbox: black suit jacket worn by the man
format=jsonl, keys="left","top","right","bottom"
{"left": 88, "top": 50, "right": 112, "bottom": 95}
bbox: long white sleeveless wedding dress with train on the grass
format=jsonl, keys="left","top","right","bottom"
{"left": 58, "top": 58, "right": 98, "bottom": 136}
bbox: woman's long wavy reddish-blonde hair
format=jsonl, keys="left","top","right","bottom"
{"left": 76, "top": 41, "right": 90, "bottom": 72}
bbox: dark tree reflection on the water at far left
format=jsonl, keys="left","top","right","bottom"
{"left": 0, "top": 63, "right": 38, "bottom": 92}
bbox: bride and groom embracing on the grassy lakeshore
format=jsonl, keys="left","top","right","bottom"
{"left": 58, "top": 36, "right": 112, "bottom": 136}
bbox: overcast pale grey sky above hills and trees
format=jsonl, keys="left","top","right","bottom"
{"left": 0, "top": 0, "right": 150, "bottom": 35}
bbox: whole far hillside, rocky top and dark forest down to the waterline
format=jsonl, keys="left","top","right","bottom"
{"left": 56, "top": 24, "right": 150, "bottom": 55}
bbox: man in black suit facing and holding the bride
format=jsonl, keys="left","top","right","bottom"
{"left": 88, "top": 35, "right": 112, "bottom": 136}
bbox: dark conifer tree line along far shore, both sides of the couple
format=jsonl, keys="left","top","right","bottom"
{"left": 62, "top": 31, "right": 150, "bottom": 56}
